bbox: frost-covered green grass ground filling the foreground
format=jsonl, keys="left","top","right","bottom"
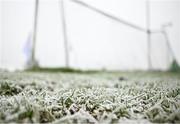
{"left": 0, "top": 72, "right": 180, "bottom": 124}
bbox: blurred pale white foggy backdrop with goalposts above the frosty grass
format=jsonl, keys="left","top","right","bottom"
{"left": 0, "top": 0, "right": 180, "bottom": 70}
